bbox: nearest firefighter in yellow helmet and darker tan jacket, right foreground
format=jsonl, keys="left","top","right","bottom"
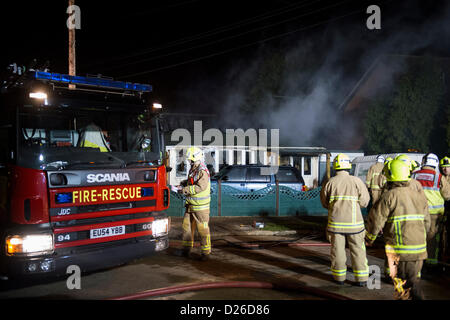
{"left": 366, "top": 160, "right": 430, "bottom": 300}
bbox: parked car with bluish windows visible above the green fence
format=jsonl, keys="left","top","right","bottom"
{"left": 211, "top": 165, "right": 306, "bottom": 192}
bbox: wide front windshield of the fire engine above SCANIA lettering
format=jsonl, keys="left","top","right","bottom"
{"left": 17, "top": 108, "right": 159, "bottom": 170}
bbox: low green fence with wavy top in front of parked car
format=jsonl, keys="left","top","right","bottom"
{"left": 166, "top": 183, "right": 328, "bottom": 217}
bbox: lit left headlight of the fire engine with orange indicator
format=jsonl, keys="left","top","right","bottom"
{"left": 6, "top": 234, "right": 54, "bottom": 255}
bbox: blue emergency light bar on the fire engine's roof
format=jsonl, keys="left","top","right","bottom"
{"left": 34, "top": 71, "right": 152, "bottom": 92}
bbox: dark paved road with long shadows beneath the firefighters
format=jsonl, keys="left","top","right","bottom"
{"left": 0, "top": 236, "right": 450, "bottom": 300}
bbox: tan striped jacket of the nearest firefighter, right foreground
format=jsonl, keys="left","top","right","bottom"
{"left": 366, "top": 182, "right": 430, "bottom": 261}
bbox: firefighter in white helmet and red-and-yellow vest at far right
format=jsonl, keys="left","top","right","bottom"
{"left": 413, "top": 153, "right": 448, "bottom": 271}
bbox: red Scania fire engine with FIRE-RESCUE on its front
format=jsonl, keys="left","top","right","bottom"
{"left": 0, "top": 71, "right": 170, "bottom": 277}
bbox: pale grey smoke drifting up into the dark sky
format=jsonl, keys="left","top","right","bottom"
{"left": 175, "top": 0, "right": 450, "bottom": 148}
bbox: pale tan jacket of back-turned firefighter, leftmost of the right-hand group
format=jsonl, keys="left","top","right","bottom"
{"left": 320, "top": 171, "right": 370, "bottom": 233}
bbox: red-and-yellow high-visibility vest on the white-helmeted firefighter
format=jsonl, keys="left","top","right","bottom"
{"left": 413, "top": 167, "right": 445, "bottom": 214}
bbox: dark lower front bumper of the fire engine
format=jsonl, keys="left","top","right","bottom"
{"left": 0, "top": 236, "right": 169, "bottom": 280}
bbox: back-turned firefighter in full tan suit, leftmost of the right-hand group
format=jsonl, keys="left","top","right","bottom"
{"left": 320, "top": 153, "right": 370, "bottom": 287}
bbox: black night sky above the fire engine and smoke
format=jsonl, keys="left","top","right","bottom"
{"left": 0, "top": 0, "right": 450, "bottom": 112}
